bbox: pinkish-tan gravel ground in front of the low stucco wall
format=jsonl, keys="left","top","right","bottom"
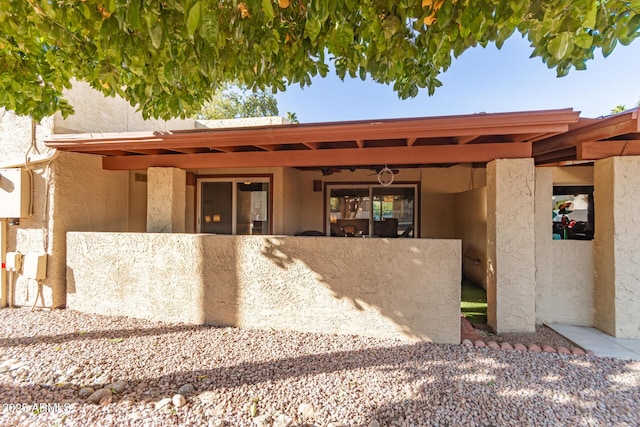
{"left": 0, "top": 309, "right": 640, "bottom": 427}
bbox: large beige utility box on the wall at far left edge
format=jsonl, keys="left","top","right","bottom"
{"left": 0, "top": 168, "right": 31, "bottom": 218}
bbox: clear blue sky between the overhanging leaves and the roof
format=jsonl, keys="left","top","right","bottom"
{"left": 277, "top": 34, "right": 640, "bottom": 123}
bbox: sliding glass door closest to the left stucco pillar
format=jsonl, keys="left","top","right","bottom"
{"left": 197, "top": 177, "right": 271, "bottom": 234}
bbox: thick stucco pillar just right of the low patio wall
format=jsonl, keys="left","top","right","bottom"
{"left": 487, "top": 159, "right": 536, "bottom": 333}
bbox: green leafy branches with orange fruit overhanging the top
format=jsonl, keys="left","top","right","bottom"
{"left": 0, "top": 0, "right": 640, "bottom": 119}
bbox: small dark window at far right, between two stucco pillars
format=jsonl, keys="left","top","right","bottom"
{"left": 552, "top": 186, "right": 595, "bottom": 240}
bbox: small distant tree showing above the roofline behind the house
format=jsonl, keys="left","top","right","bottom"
{"left": 197, "top": 83, "right": 278, "bottom": 119}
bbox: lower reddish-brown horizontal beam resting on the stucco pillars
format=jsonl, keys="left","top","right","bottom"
{"left": 102, "top": 142, "right": 531, "bottom": 170}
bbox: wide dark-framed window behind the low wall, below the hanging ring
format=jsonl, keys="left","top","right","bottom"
{"left": 327, "top": 184, "right": 417, "bottom": 237}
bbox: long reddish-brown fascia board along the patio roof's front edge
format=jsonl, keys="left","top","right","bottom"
{"left": 47, "top": 109, "right": 579, "bottom": 152}
